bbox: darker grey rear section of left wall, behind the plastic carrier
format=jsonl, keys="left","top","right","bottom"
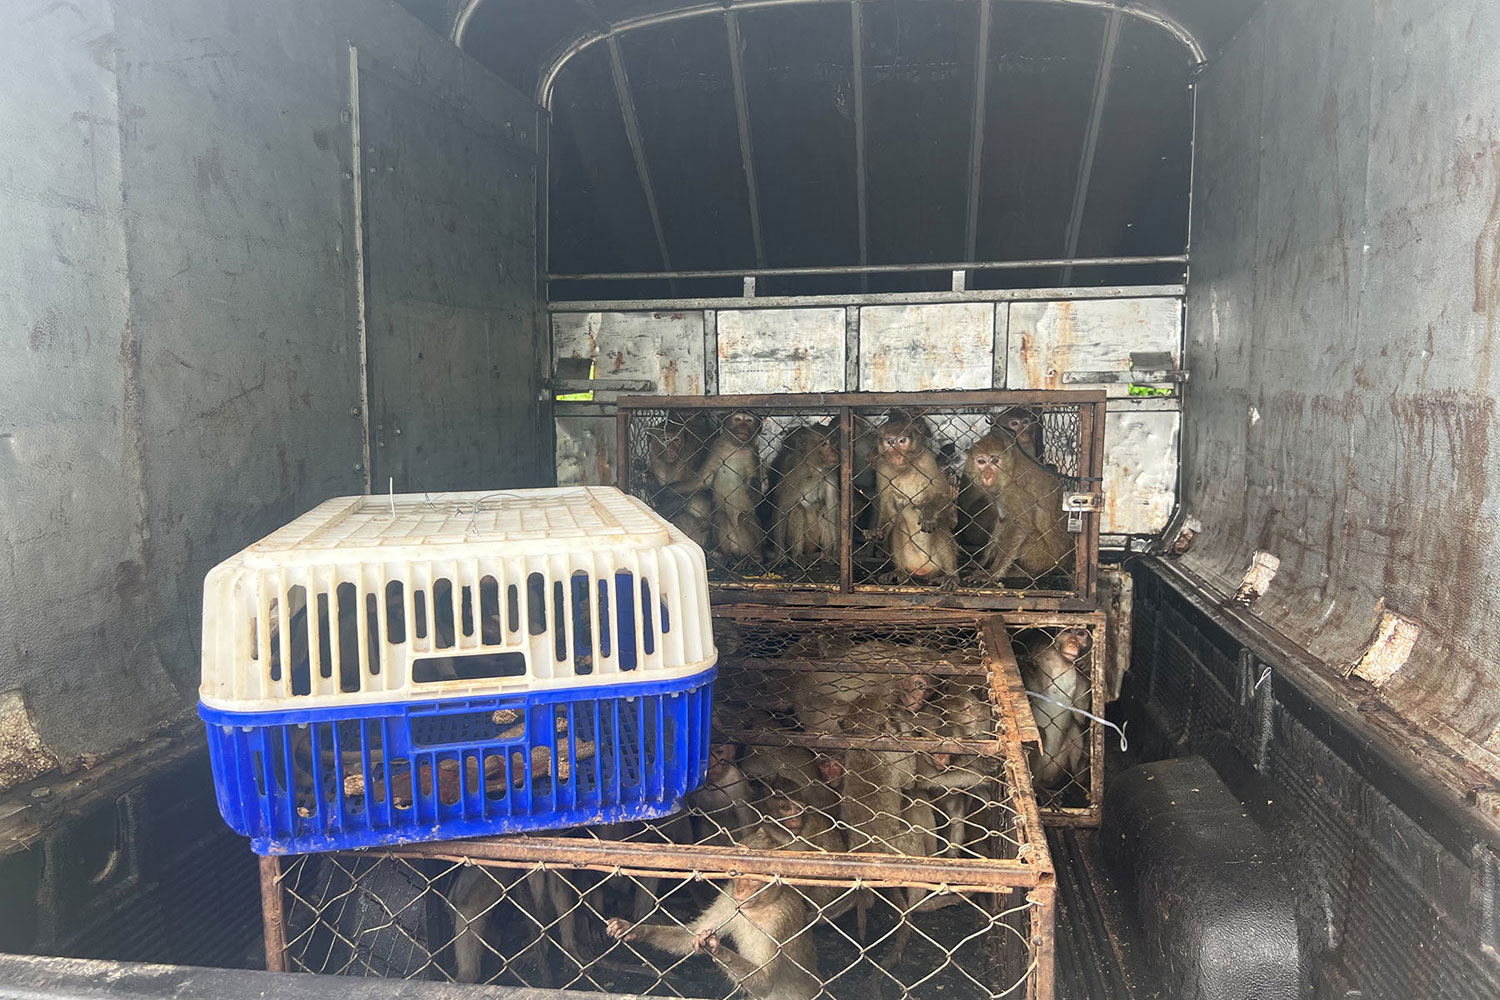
{"left": 360, "top": 55, "right": 551, "bottom": 492}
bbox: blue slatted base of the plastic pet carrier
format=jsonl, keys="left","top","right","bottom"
{"left": 198, "top": 667, "right": 717, "bottom": 855}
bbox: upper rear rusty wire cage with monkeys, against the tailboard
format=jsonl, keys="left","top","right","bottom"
{"left": 618, "top": 391, "right": 1104, "bottom": 610}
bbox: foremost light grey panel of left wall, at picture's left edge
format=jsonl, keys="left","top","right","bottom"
{"left": 0, "top": 0, "right": 180, "bottom": 786}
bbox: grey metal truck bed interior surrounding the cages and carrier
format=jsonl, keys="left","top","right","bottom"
{"left": 0, "top": 0, "right": 1500, "bottom": 1000}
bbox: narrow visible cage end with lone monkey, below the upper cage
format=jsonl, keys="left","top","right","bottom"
{"left": 986, "top": 612, "right": 1107, "bottom": 826}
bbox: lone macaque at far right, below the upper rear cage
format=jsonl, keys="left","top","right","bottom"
{"left": 1022, "top": 628, "right": 1094, "bottom": 787}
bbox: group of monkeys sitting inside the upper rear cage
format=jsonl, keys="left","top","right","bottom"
{"left": 645, "top": 406, "right": 1074, "bottom": 588}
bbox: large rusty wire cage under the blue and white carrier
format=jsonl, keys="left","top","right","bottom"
{"left": 263, "top": 612, "right": 1055, "bottom": 1000}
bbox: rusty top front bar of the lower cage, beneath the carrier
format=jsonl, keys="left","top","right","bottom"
{"left": 384, "top": 837, "right": 1050, "bottom": 892}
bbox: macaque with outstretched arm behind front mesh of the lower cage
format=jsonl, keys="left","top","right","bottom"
{"left": 605, "top": 829, "right": 822, "bottom": 1000}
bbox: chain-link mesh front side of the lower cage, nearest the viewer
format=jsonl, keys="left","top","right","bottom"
{"left": 281, "top": 853, "right": 1038, "bottom": 1000}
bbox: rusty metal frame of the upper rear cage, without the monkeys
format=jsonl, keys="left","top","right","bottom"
{"left": 617, "top": 390, "right": 1107, "bottom": 612}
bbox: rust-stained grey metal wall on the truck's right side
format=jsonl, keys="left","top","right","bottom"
{"left": 1185, "top": 0, "right": 1500, "bottom": 774}
